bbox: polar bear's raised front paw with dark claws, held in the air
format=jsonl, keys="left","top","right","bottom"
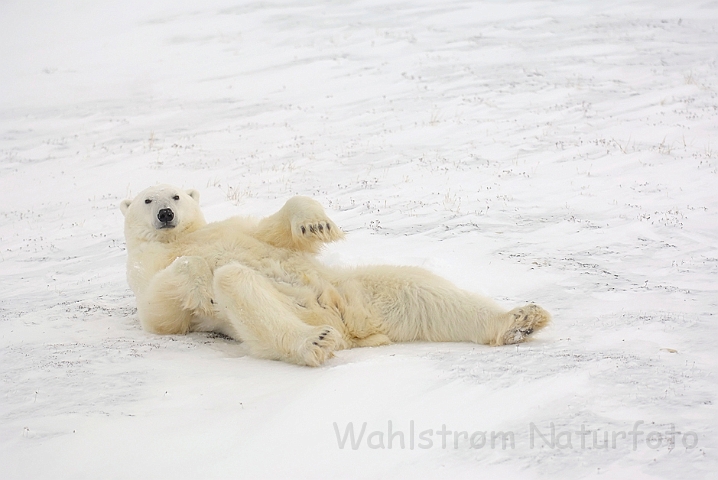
{"left": 255, "top": 197, "right": 344, "bottom": 253}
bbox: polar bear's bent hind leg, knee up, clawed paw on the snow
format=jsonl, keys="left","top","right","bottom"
{"left": 214, "top": 264, "right": 345, "bottom": 367}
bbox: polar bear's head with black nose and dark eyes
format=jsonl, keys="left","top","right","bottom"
{"left": 120, "top": 185, "right": 207, "bottom": 242}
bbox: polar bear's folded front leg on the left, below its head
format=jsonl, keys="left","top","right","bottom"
{"left": 137, "top": 256, "right": 214, "bottom": 334}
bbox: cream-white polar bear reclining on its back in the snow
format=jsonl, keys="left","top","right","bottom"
{"left": 120, "top": 185, "right": 551, "bottom": 366}
